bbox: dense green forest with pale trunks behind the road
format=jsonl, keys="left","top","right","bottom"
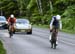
{"left": 0, "top": 0, "right": 75, "bottom": 32}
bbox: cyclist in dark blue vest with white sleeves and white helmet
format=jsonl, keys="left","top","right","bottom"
{"left": 50, "top": 15, "right": 62, "bottom": 45}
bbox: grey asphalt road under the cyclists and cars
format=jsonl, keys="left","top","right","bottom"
{"left": 0, "top": 28, "right": 75, "bottom": 54}
